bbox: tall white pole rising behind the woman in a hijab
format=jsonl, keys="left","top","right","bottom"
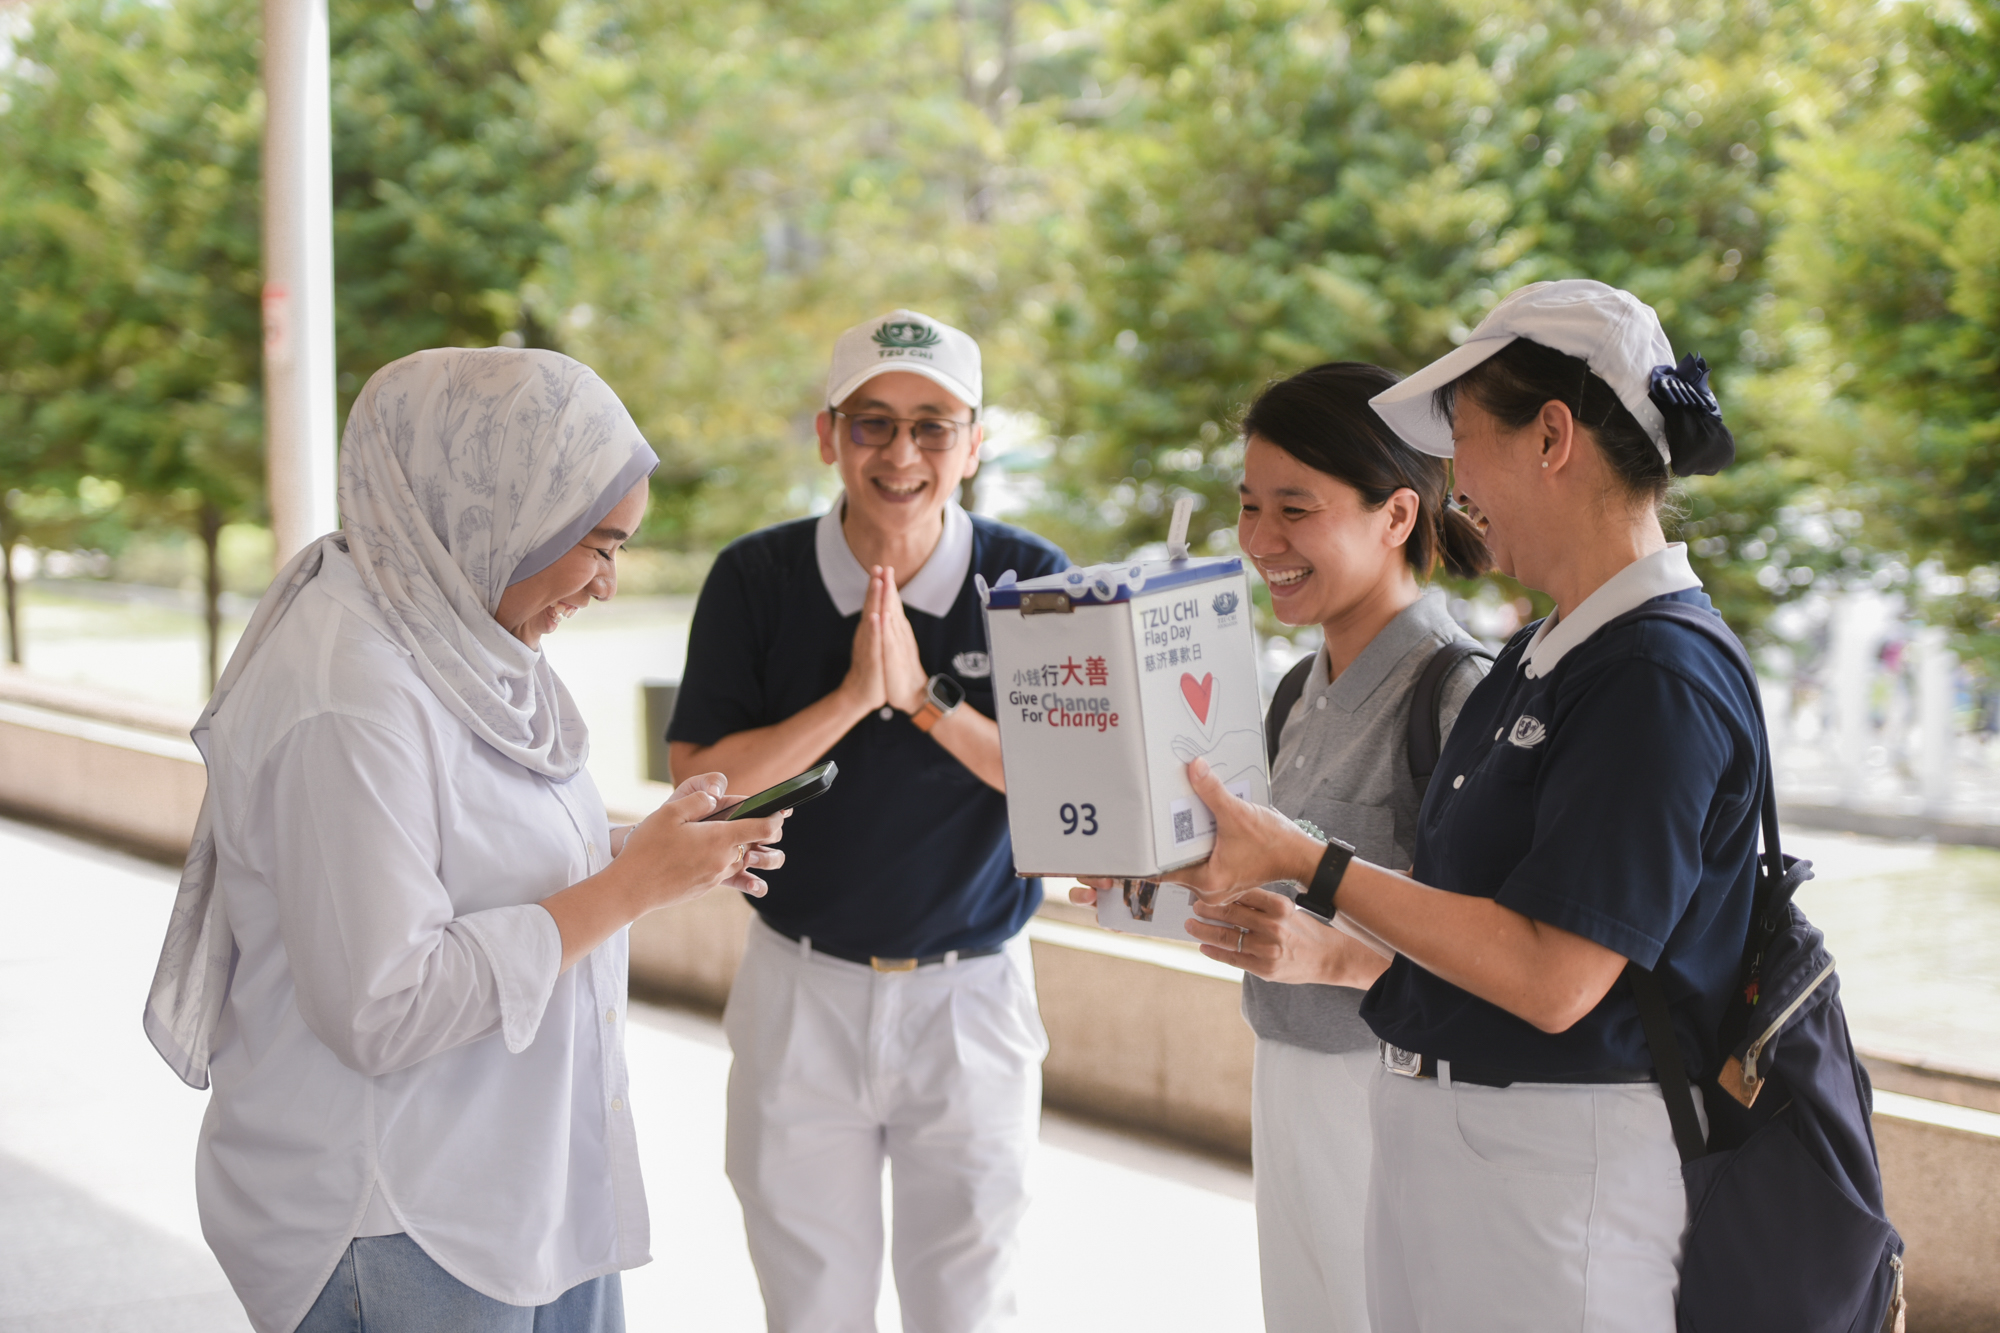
{"left": 264, "top": 0, "right": 340, "bottom": 566}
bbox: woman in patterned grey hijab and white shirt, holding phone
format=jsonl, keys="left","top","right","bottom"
{"left": 146, "top": 348, "right": 782, "bottom": 1333}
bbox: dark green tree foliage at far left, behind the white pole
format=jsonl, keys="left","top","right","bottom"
{"left": 0, "top": 0, "right": 594, "bottom": 673}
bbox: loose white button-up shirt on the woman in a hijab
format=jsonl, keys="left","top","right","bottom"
{"left": 196, "top": 552, "right": 650, "bottom": 1333}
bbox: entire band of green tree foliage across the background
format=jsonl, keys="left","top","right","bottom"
{"left": 0, "top": 0, "right": 2000, "bottom": 660}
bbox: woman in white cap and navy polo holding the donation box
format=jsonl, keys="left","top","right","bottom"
{"left": 1186, "top": 280, "right": 1768, "bottom": 1333}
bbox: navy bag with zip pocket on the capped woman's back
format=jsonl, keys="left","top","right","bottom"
{"left": 1612, "top": 602, "right": 1904, "bottom": 1333}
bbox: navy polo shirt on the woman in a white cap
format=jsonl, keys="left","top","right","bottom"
{"left": 1362, "top": 590, "right": 1764, "bottom": 1077}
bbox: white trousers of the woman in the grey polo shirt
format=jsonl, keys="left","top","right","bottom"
{"left": 1250, "top": 1039, "right": 1382, "bottom": 1333}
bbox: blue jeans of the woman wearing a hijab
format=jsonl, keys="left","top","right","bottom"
{"left": 298, "top": 1235, "right": 624, "bottom": 1333}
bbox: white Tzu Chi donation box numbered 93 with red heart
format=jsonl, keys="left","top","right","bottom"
{"left": 980, "top": 558, "right": 1270, "bottom": 879}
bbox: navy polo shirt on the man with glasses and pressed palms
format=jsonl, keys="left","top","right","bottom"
{"left": 666, "top": 516, "right": 1070, "bottom": 959}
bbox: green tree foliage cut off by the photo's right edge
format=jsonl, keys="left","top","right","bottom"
{"left": 1772, "top": 0, "right": 2000, "bottom": 656}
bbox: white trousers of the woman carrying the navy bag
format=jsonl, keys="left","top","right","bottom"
{"left": 1368, "top": 1073, "right": 1688, "bottom": 1333}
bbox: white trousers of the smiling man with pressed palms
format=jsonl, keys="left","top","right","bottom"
{"left": 722, "top": 921, "right": 1048, "bottom": 1333}
